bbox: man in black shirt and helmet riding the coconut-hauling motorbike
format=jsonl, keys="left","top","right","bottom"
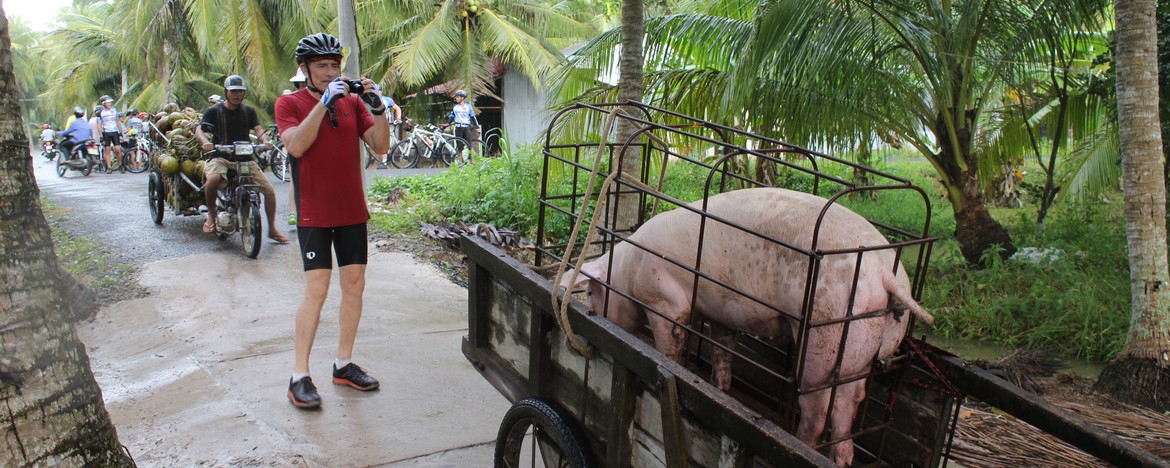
{"left": 195, "top": 75, "right": 289, "bottom": 243}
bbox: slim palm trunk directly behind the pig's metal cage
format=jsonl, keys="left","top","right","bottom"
{"left": 613, "top": 0, "right": 646, "bottom": 229}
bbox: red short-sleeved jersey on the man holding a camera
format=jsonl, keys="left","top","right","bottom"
{"left": 276, "top": 89, "right": 373, "bottom": 227}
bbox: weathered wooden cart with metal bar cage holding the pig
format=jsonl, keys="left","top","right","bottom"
{"left": 461, "top": 102, "right": 1165, "bottom": 467}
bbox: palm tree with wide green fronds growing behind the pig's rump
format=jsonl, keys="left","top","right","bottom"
{"left": 734, "top": 0, "right": 1108, "bottom": 263}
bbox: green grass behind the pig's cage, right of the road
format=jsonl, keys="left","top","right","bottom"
{"left": 370, "top": 147, "right": 1130, "bottom": 360}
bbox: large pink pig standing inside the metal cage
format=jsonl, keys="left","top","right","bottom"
{"left": 562, "top": 188, "right": 934, "bottom": 467}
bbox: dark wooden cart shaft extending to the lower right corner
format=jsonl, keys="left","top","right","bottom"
{"left": 930, "top": 353, "right": 1170, "bottom": 467}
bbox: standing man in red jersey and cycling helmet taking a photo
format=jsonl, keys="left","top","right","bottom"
{"left": 276, "top": 33, "right": 390, "bottom": 408}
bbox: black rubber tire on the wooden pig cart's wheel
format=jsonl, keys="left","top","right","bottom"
{"left": 494, "top": 398, "right": 598, "bottom": 468}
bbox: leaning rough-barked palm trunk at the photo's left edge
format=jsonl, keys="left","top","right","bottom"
{"left": 0, "top": 8, "right": 133, "bottom": 467}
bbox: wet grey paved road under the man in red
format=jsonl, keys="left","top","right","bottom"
{"left": 34, "top": 156, "right": 508, "bottom": 467}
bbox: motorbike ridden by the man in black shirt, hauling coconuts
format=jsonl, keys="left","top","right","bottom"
{"left": 206, "top": 142, "right": 264, "bottom": 259}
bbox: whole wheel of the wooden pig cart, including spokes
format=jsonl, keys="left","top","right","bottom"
{"left": 495, "top": 398, "right": 597, "bottom": 468}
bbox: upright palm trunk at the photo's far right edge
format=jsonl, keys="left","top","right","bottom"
{"left": 1097, "top": 0, "right": 1170, "bottom": 411}
